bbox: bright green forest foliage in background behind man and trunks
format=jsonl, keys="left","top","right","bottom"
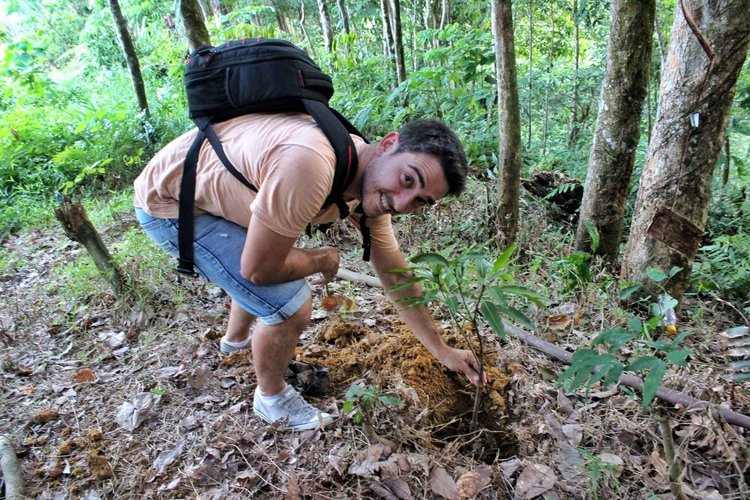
{"left": 0, "top": 0, "right": 750, "bottom": 298}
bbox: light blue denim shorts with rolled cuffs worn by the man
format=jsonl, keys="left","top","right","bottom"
{"left": 135, "top": 208, "right": 311, "bottom": 325}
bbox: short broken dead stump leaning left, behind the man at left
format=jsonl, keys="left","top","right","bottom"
{"left": 55, "top": 197, "right": 126, "bottom": 299}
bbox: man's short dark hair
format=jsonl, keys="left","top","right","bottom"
{"left": 396, "top": 120, "right": 469, "bottom": 194}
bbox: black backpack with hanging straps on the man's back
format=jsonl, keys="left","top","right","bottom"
{"left": 177, "top": 39, "right": 370, "bottom": 275}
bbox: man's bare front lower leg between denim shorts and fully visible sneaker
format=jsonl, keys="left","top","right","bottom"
{"left": 253, "top": 298, "right": 312, "bottom": 396}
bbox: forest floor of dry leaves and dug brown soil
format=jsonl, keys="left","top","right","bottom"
{"left": 0, "top": 189, "right": 750, "bottom": 500}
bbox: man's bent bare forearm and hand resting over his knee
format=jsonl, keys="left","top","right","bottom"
{"left": 240, "top": 217, "right": 339, "bottom": 285}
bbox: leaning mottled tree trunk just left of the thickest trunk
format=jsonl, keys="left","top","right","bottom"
{"left": 575, "top": 0, "right": 656, "bottom": 262}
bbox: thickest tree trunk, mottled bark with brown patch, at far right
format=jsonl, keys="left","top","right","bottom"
{"left": 622, "top": 0, "right": 750, "bottom": 300}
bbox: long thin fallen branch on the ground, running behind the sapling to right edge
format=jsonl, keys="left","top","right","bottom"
{"left": 347, "top": 271, "right": 750, "bottom": 429}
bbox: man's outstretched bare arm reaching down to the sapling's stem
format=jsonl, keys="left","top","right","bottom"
{"left": 372, "top": 249, "right": 487, "bottom": 385}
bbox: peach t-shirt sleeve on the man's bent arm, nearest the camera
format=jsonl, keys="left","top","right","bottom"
{"left": 250, "top": 145, "right": 335, "bottom": 238}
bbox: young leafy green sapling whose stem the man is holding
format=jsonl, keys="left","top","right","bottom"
{"left": 397, "top": 245, "right": 543, "bottom": 432}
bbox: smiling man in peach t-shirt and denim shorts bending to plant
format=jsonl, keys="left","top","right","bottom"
{"left": 134, "top": 113, "right": 488, "bottom": 430}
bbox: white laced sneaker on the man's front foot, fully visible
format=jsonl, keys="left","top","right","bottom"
{"left": 253, "top": 385, "right": 333, "bottom": 431}
